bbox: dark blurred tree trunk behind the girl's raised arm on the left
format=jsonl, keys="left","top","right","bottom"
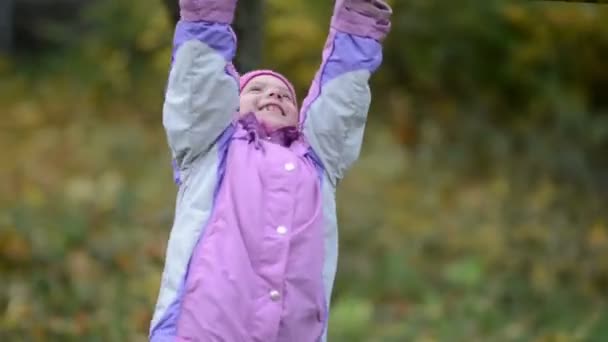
{"left": 163, "top": 0, "right": 264, "bottom": 73}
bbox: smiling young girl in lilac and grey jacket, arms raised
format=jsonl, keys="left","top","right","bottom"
{"left": 150, "top": 0, "right": 391, "bottom": 342}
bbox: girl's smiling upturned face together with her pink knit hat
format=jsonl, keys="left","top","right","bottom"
{"left": 240, "top": 75, "right": 298, "bottom": 131}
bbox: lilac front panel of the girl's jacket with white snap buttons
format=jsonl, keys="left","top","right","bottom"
{"left": 177, "top": 121, "right": 326, "bottom": 342}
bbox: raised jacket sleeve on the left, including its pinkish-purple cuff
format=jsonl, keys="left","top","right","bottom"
{"left": 163, "top": 0, "right": 239, "bottom": 169}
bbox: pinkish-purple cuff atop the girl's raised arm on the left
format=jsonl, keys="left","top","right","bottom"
{"left": 179, "top": 0, "right": 237, "bottom": 24}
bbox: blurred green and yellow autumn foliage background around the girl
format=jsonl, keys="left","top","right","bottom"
{"left": 0, "top": 0, "right": 608, "bottom": 342}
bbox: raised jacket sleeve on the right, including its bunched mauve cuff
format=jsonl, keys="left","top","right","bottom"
{"left": 300, "top": 0, "right": 392, "bottom": 186}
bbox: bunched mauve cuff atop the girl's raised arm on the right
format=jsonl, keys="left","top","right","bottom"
{"left": 331, "top": 0, "right": 393, "bottom": 41}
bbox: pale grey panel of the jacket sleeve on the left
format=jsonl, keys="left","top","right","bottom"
{"left": 163, "top": 40, "right": 239, "bottom": 169}
